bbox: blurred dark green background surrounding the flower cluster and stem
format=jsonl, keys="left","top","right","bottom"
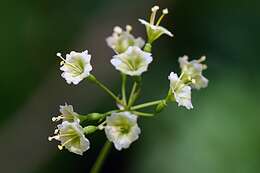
{"left": 0, "top": 0, "right": 260, "bottom": 173}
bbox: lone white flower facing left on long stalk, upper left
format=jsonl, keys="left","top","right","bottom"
{"left": 57, "top": 50, "right": 92, "bottom": 85}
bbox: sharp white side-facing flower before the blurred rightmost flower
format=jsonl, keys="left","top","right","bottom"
{"left": 168, "top": 72, "right": 193, "bottom": 109}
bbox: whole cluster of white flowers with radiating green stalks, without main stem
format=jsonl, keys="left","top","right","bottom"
{"left": 49, "top": 3, "right": 208, "bottom": 169}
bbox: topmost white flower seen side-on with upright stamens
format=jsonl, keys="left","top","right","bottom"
{"left": 139, "top": 6, "right": 173, "bottom": 44}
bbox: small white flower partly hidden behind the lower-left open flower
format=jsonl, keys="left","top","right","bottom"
{"left": 52, "top": 103, "right": 80, "bottom": 122}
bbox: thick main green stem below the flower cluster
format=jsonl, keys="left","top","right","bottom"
{"left": 90, "top": 141, "right": 112, "bottom": 173}
